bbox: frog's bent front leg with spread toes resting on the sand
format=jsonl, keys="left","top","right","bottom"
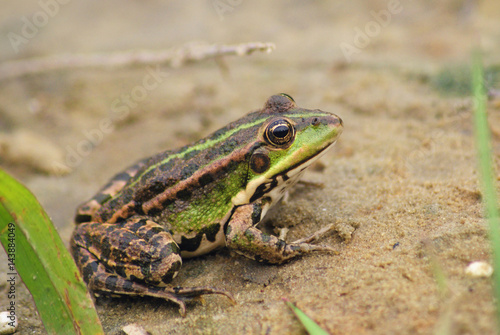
{"left": 226, "top": 202, "right": 335, "bottom": 263}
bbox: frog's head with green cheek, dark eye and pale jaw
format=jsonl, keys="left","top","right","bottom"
{"left": 233, "top": 94, "right": 343, "bottom": 205}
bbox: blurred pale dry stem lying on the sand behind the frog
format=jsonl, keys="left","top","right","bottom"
{"left": 0, "top": 42, "right": 275, "bottom": 81}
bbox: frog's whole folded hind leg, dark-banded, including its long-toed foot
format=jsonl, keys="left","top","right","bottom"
{"left": 71, "top": 216, "right": 234, "bottom": 315}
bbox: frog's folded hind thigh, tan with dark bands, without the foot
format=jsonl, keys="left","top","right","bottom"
{"left": 72, "top": 217, "right": 182, "bottom": 291}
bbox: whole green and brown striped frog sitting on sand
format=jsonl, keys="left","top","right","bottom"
{"left": 70, "top": 93, "right": 343, "bottom": 315}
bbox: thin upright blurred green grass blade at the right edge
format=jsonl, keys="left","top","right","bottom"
{"left": 472, "top": 53, "right": 500, "bottom": 323}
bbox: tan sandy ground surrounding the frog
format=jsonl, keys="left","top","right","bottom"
{"left": 0, "top": 0, "right": 500, "bottom": 334}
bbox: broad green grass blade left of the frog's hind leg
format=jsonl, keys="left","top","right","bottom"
{"left": 0, "top": 170, "right": 104, "bottom": 335}
